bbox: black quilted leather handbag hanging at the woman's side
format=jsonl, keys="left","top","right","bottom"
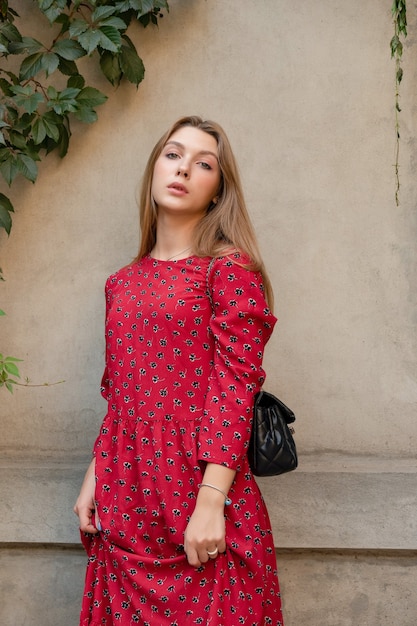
{"left": 248, "top": 391, "right": 298, "bottom": 476}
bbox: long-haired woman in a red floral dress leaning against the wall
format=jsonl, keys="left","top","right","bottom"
{"left": 74, "top": 117, "right": 283, "bottom": 626}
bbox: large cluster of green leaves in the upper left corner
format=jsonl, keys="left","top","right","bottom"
{"left": 0, "top": 0, "right": 169, "bottom": 229}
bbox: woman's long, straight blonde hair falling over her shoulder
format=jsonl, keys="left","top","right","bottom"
{"left": 136, "top": 115, "right": 273, "bottom": 308}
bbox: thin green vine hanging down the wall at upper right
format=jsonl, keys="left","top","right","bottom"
{"left": 390, "top": 0, "right": 407, "bottom": 206}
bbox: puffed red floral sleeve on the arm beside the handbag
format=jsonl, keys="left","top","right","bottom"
{"left": 199, "top": 254, "right": 277, "bottom": 470}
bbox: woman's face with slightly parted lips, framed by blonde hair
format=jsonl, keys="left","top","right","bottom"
{"left": 152, "top": 126, "right": 220, "bottom": 218}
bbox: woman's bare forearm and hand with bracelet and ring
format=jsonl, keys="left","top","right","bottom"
{"left": 184, "top": 463, "right": 236, "bottom": 567}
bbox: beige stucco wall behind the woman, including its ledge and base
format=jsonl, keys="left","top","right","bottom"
{"left": 0, "top": 0, "right": 417, "bottom": 626}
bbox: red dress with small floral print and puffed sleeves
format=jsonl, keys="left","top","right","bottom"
{"left": 80, "top": 254, "right": 283, "bottom": 626}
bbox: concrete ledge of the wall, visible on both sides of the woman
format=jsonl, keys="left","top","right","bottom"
{"left": 0, "top": 455, "right": 417, "bottom": 550}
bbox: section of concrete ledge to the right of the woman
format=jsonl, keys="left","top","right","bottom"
{"left": 258, "top": 454, "right": 417, "bottom": 550}
